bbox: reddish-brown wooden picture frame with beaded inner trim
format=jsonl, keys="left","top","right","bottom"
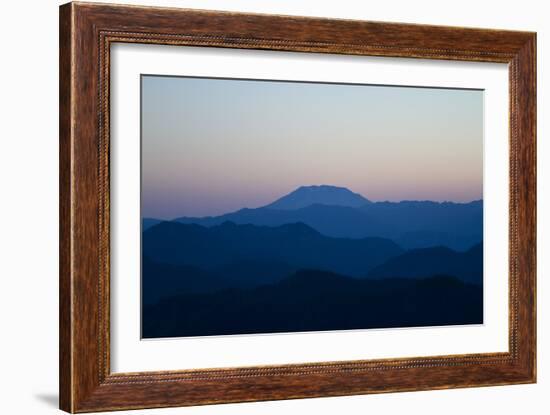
{"left": 59, "top": 3, "right": 536, "bottom": 413}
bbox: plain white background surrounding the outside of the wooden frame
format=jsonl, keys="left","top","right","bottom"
{"left": 0, "top": 0, "right": 550, "bottom": 415}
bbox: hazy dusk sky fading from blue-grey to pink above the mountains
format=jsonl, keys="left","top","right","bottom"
{"left": 142, "top": 76, "right": 483, "bottom": 218}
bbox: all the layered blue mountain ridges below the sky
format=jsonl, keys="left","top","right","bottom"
{"left": 142, "top": 186, "right": 483, "bottom": 338}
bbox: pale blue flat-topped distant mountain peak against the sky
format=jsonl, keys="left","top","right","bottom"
{"left": 264, "top": 184, "right": 370, "bottom": 210}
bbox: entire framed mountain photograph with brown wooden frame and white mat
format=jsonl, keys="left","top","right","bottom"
{"left": 60, "top": 3, "right": 536, "bottom": 413}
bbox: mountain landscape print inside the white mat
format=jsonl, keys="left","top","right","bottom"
{"left": 141, "top": 75, "right": 483, "bottom": 339}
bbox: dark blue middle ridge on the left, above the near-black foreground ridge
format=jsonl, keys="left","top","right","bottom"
{"left": 142, "top": 222, "right": 404, "bottom": 278}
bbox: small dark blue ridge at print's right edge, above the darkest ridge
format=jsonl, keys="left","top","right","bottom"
{"left": 368, "top": 244, "right": 483, "bottom": 285}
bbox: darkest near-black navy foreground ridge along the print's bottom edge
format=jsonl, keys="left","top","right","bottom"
{"left": 142, "top": 270, "right": 483, "bottom": 338}
